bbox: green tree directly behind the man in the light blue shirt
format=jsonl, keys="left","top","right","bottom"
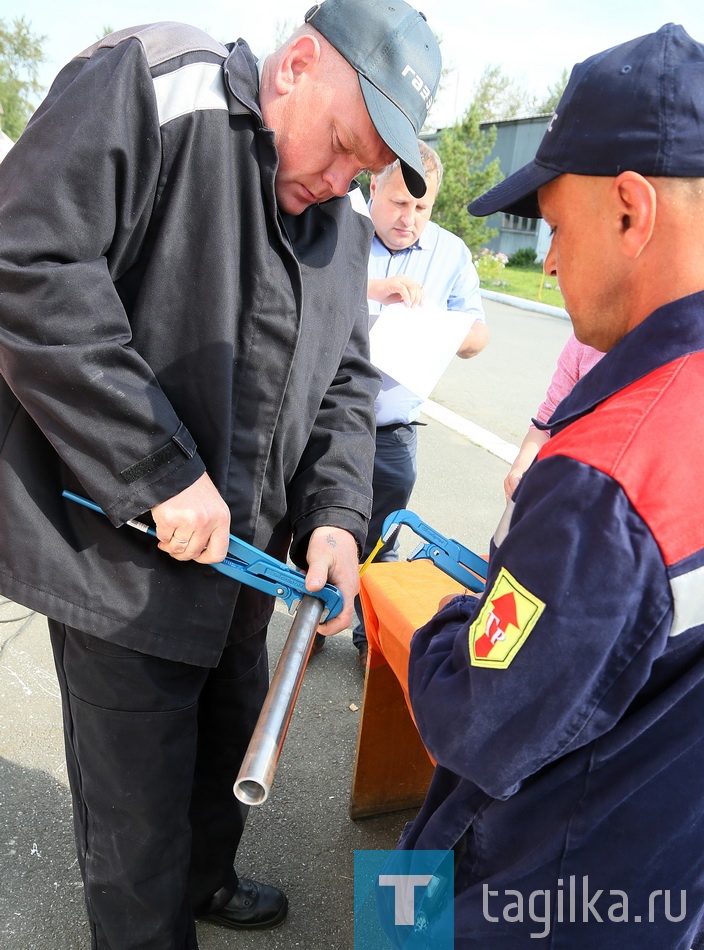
{"left": 433, "top": 101, "right": 503, "bottom": 253}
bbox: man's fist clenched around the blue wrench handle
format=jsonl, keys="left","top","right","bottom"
{"left": 152, "top": 473, "right": 230, "bottom": 564}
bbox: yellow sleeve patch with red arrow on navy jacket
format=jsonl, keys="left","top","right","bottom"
{"left": 469, "top": 567, "right": 545, "bottom": 670}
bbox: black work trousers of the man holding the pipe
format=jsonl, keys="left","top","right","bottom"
{"left": 49, "top": 621, "right": 269, "bottom": 950}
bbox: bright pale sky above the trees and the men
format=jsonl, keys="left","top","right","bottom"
{"left": 13, "top": 0, "right": 704, "bottom": 127}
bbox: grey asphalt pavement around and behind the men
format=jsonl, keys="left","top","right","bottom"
{"left": 0, "top": 303, "right": 569, "bottom": 950}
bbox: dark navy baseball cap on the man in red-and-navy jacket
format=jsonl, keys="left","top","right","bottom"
{"left": 467, "top": 23, "right": 704, "bottom": 218}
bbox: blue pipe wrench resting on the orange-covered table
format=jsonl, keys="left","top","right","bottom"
{"left": 362, "top": 508, "right": 487, "bottom": 593}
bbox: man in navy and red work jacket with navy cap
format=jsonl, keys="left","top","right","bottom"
{"left": 398, "top": 24, "right": 704, "bottom": 950}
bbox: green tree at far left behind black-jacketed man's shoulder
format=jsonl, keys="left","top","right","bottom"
{"left": 0, "top": 17, "right": 46, "bottom": 140}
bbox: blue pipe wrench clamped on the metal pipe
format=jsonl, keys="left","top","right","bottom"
{"left": 62, "top": 491, "right": 343, "bottom": 620}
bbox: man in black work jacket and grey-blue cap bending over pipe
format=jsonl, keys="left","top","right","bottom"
{"left": 0, "top": 0, "right": 440, "bottom": 950}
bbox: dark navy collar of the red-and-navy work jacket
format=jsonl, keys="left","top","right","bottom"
{"left": 533, "top": 291, "right": 704, "bottom": 435}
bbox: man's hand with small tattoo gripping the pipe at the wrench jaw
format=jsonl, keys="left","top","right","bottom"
{"left": 306, "top": 525, "right": 359, "bottom": 636}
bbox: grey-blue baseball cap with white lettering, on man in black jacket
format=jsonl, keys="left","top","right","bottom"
{"left": 305, "top": 0, "right": 442, "bottom": 198}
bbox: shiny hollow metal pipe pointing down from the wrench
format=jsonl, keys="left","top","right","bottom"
{"left": 234, "top": 595, "right": 325, "bottom": 805}
